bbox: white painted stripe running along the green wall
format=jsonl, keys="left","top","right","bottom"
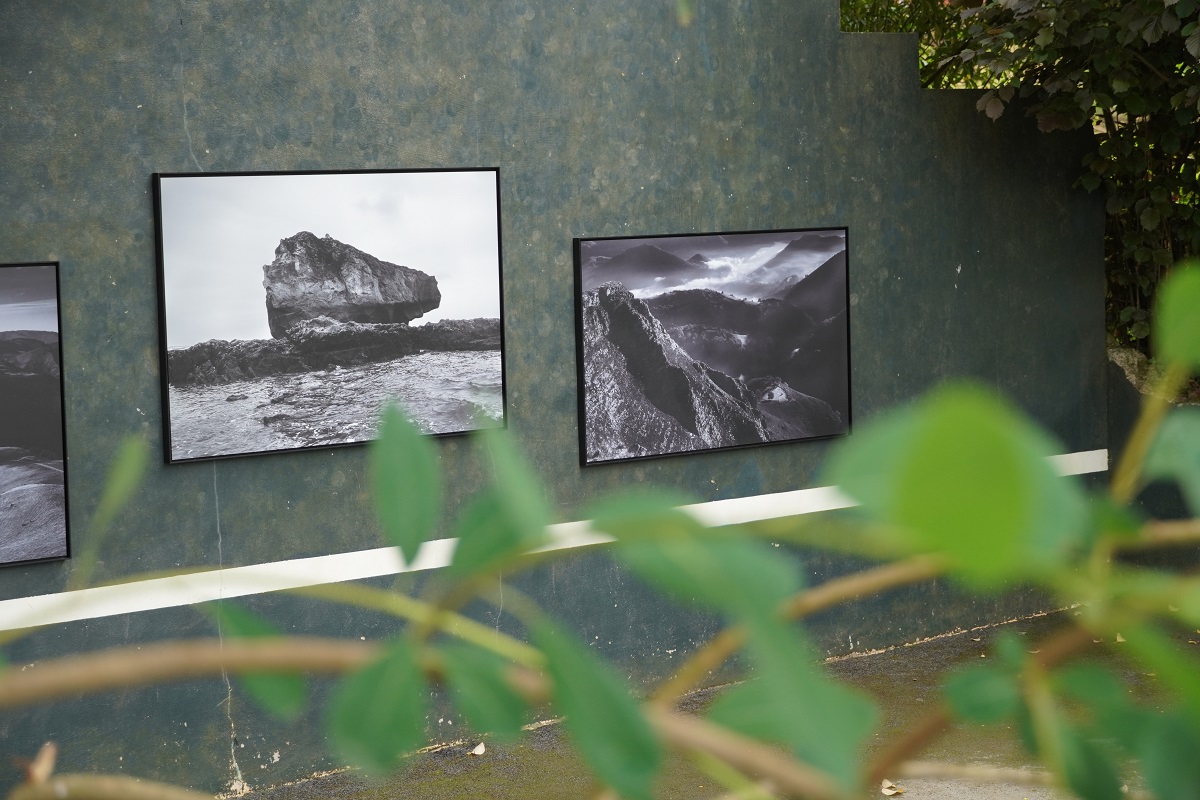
{"left": 0, "top": 450, "right": 1109, "bottom": 631}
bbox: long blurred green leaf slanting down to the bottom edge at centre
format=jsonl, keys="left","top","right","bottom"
{"left": 530, "top": 620, "right": 662, "bottom": 800}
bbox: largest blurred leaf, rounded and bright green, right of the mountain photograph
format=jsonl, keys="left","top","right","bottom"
{"left": 830, "top": 384, "right": 1087, "bottom": 589}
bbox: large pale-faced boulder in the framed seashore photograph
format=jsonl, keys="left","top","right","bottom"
{"left": 263, "top": 230, "right": 442, "bottom": 338}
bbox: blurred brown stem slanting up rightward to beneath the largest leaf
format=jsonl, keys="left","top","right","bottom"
{"left": 650, "top": 555, "right": 944, "bottom": 705}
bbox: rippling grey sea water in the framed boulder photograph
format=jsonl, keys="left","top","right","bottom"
{"left": 169, "top": 350, "right": 504, "bottom": 461}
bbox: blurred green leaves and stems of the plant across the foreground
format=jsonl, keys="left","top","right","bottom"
{"left": 7, "top": 253, "right": 1200, "bottom": 800}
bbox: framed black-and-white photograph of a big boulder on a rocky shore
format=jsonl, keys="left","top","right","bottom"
{"left": 154, "top": 168, "right": 505, "bottom": 463}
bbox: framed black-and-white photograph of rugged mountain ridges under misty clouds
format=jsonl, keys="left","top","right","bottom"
{"left": 575, "top": 228, "right": 850, "bottom": 467}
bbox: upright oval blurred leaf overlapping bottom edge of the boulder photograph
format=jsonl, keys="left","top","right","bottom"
{"left": 368, "top": 404, "right": 442, "bottom": 563}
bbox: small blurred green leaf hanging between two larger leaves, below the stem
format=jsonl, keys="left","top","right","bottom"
{"left": 440, "top": 644, "right": 526, "bottom": 741}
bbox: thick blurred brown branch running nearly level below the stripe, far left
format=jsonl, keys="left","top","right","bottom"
{"left": 0, "top": 637, "right": 378, "bottom": 709}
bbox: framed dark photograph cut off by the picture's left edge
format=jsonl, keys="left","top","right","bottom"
{"left": 0, "top": 263, "right": 71, "bottom": 564}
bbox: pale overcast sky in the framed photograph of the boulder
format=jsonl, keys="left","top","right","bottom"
{"left": 160, "top": 170, "right": 500, "bottom": 349}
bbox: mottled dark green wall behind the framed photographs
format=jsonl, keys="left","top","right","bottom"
{"left": 0, "top": 0, "right": 1106, "bottom": 789}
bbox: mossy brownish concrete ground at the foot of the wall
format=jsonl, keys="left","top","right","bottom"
{"left": 245, "top": 616, "right": 1150, "bottom": 800}
